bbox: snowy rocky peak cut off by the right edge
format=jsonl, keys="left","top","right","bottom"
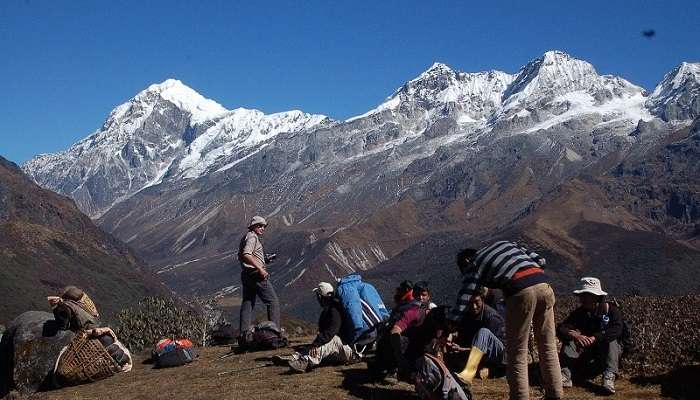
{"left": 646, "top": 62, "right": 700, "bottom": 121}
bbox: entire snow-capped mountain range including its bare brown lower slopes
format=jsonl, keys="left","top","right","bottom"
{"left": 25, "top": 51, "right": 700, "bottom": 310}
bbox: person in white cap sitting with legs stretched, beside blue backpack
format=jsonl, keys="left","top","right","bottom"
{"left": 288, "top": 282, "right": 360, "bottom": 372}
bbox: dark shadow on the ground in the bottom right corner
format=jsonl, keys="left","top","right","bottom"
{"left": 631, "top": 364, "right": 700, "bottom": 400}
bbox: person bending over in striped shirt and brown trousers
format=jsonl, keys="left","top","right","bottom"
{"left": 450, "top": 241, "right": 563, "bottom": 400}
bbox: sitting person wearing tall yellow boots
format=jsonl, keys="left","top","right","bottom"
{"left": 449, "top": 288, "right": 506, "bottom": 385}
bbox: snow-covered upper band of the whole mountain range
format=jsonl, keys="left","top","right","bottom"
{"left": 24, "top": 51, "right": 700, "bottom": 220}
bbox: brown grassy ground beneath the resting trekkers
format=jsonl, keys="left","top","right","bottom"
{"left": 32, "top": 340, "right": 663, "bottom": 400}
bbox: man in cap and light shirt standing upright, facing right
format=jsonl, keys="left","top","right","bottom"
{"left": 238, "top": 215, "right": 281, "bottom": 350}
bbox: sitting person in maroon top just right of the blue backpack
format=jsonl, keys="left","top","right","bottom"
{"left": 368, "top": 281, "right": 428, "bottom": 382}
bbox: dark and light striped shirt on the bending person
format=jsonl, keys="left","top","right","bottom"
{"left": 450, "top": 241, "right": 546, "bottom": 321}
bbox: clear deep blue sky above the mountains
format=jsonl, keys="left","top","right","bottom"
{"left": 0, "top": 0, "right": 700, "bottom": 163}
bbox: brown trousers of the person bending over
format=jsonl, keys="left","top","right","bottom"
{"left": 506, "top": 283, "right": 564, "bottom": 400}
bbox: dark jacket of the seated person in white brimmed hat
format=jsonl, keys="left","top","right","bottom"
{"left": 557, "top": 303, "right": 623, "bottom": 343}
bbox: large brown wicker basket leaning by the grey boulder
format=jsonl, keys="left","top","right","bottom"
{"left": 56, "top": 333, "right": 119, "bottom": 386}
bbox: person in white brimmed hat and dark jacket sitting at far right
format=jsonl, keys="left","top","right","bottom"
{"left": 557, "top": 277, "right": 623, "bottom": 394}
